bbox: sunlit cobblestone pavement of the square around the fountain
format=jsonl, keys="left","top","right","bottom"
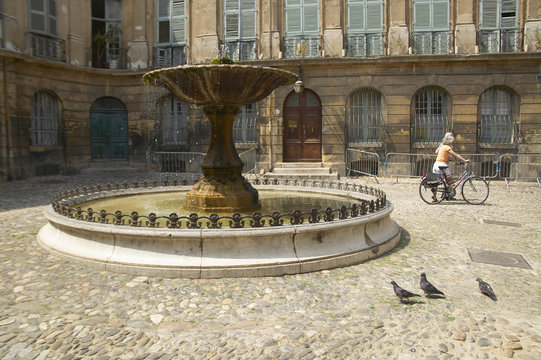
{"left": 0, "top": 175, "right": 541, "bottom": 360}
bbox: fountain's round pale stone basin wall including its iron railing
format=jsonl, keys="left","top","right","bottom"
{"left": 37, "top": 182, "right": 400, "bottom": 278}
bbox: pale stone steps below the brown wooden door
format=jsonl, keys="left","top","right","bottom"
{"left": 265, "top": 162, "right": 339, "bottom": 180}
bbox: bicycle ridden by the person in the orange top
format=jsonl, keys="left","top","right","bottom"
{"left": 419, "top": 163, "right": 490, "bottom": 205}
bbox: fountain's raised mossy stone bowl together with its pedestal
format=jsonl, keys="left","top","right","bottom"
{"left": 143, "top": 65, "right": 297, "bottom": 212}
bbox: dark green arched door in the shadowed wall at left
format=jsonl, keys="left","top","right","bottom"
{"left": 90, "top": 100, "right": 128, "bottom": 160}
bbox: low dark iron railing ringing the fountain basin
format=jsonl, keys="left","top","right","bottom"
{"left": 51, "top": 178, "right": 389, "bottom": 229}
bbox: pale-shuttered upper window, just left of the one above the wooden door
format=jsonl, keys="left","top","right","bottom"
{"left": 224, "top": 0, "right": 257, "bottom": 60}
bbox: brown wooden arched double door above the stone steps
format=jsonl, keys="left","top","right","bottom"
{"left": 283, "top": 89, "right": 321, "bottom": 162}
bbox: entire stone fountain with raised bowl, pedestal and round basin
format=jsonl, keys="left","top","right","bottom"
{"left": 37, "top": 65, "right": 400, "bottom": 278}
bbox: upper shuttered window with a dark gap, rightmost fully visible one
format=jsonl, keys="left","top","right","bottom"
{"left": 479, "top": 0, "right": 518, "bottom": 53}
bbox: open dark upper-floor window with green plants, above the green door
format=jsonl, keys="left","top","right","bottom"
{"left": 92, "top": 0, "right": 122, "bottom": 68}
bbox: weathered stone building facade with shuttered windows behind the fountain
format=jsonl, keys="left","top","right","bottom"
{"left": 0, "top": 0, "right": 541, "bottom": 180}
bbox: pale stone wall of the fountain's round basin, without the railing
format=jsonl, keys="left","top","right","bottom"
{"left": 38, "top": 180, "right": 400, "bottom": 278}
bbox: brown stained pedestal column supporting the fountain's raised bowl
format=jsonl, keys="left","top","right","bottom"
{"left": 184, "top": 105, "right": 261, "bottom": 212}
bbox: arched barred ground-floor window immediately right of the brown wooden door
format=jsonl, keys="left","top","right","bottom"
{"left": 348, "top": 89, "right": 382, "bottom": 146}
